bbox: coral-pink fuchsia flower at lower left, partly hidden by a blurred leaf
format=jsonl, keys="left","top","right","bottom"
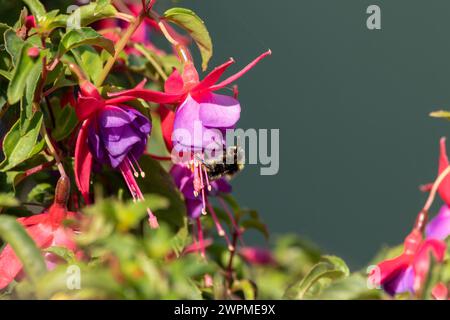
{"left": 0, "top": 177, "right": 79, "bottom": 289}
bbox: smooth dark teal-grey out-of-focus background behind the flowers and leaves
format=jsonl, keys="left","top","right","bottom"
{"left": 0, "top": 0, "right": 450, "bottom": 269}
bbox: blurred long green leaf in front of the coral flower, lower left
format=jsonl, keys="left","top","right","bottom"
{"left": 0, "top": 215, "right": 47, "bottom": 282}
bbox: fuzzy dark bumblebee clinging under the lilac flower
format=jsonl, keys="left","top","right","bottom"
{"left": 202, "top": 146, "right": 244, "bottom": 181}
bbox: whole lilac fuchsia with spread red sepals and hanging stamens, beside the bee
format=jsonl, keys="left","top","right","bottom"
{"left": 110, "top": 50, "right": 271, "bottom": 216}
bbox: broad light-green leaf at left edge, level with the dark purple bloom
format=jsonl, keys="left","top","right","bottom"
{"left": 0, "top": 112, "right": 42, "bottom": 172}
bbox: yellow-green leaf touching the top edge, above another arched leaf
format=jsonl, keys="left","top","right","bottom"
{"left": 67, "top": 0, "right": 117, "bottom": 29}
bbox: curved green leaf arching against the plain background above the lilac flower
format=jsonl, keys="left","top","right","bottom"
{"left": 163, "top": 8, "right": 213, "bottom": 71}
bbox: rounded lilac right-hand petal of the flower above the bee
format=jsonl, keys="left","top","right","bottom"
{"left": 199, "top": 93, "right": 241, "bottom": 128}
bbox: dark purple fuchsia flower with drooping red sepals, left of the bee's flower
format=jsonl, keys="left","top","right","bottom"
{"left": 71, "top": 71, "right": 158, "bottom": 228}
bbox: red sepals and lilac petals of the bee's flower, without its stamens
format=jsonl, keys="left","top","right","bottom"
{"left": 111, "top": 50, "right": 271, "bottom": 151}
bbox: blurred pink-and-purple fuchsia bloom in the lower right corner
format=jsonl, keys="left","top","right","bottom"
{"left": 369, "top": 228, "right": 446, "bottom": 295}
